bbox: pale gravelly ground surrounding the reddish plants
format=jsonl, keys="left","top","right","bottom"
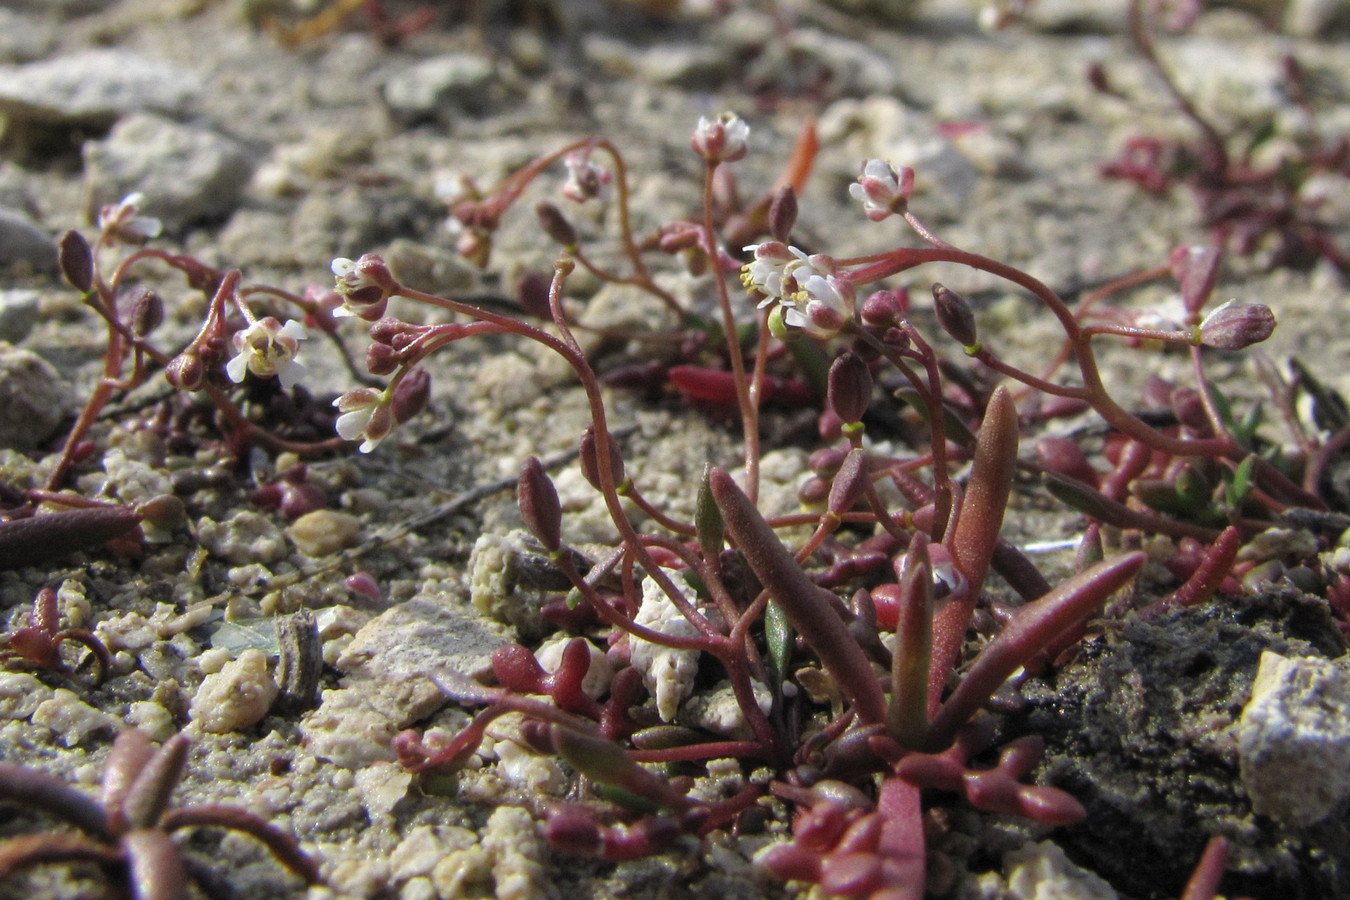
{"left": 0, "top": 0, "right": 1350, "bottom": 900}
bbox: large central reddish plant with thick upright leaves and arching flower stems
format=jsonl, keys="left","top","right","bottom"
{"left": 318, "top": 115, "right": 1296, "bottom": 897}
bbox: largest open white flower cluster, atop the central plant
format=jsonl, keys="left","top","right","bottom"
{"left": 741, "top": 240, "right": 857, "bottom": 340}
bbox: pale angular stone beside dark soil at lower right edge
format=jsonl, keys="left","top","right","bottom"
{"left": 1237, "top": 650, "right": 1350, "bottom": 827}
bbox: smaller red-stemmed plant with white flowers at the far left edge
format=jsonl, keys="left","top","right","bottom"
{"left": 0, "top": 194, "right": 425, "bottom": 568}
